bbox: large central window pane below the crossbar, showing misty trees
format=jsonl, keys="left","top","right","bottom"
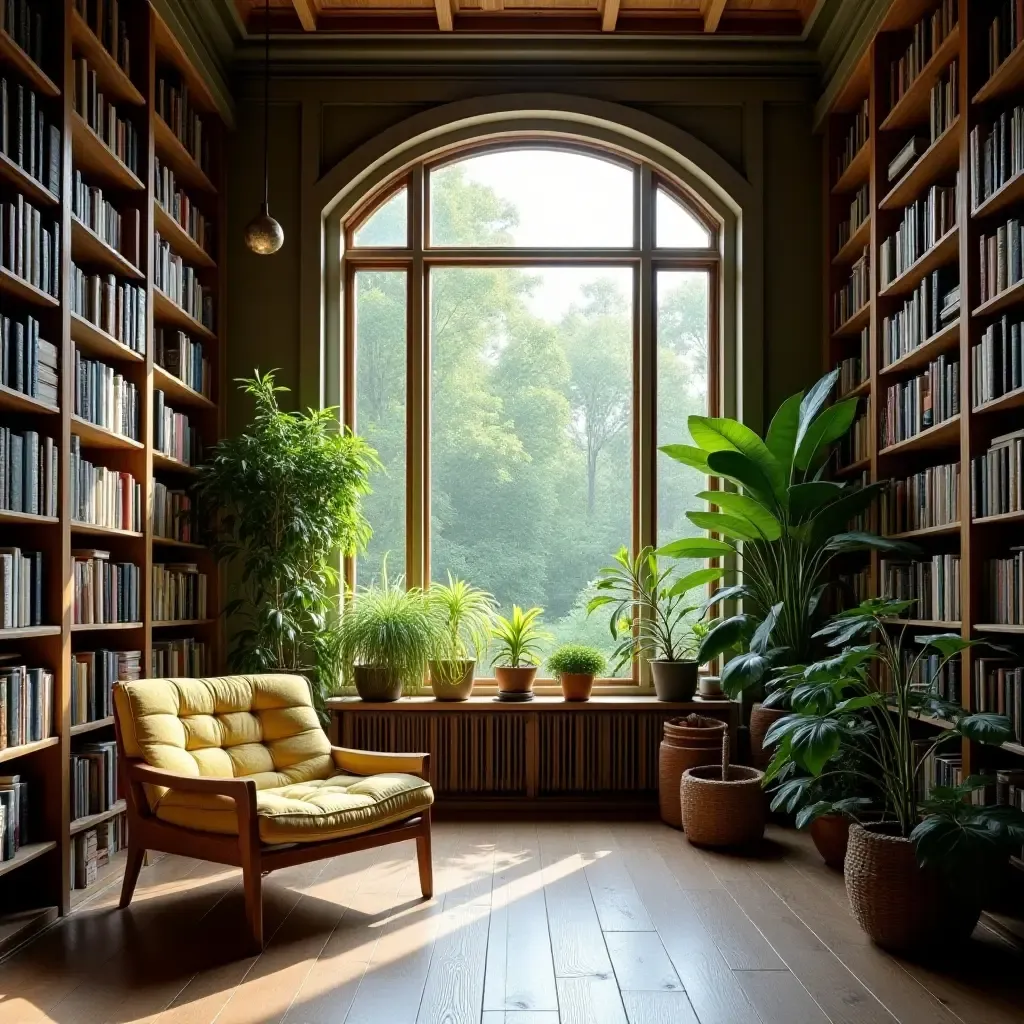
{"left": 430, "top": 267, "right": 633, "bottom": 675}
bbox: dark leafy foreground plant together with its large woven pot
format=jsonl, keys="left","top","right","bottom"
{"left": 765, "top": 599, "right": 1024, "bottom": 950}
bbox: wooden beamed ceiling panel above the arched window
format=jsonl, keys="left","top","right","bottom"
{"left": 234, "top": 0, "right": 818, "bottom": 37}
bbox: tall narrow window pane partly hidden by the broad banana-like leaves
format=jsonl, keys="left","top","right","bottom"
{"left": 655, "top": 270, "right": 710, "bottom": 572}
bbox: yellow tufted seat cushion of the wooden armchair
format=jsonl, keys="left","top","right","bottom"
{"left": 156, "top": 772, "right": 433, "bottom": 843}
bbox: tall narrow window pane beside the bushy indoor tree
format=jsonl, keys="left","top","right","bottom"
{"left": 355, "top": 270, "right": 407, "bottom": 584}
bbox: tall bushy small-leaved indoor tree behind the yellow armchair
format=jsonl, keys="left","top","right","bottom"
{"left": 197, "top": 370, "right": 379, "bottom": 695}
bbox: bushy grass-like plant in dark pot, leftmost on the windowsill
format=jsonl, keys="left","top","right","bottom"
{"left": 339, "top": 563, "right": 438, "bottom": 701}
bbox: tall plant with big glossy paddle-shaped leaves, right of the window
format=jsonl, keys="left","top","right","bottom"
{"left": 657, "top": 370, "right": 913, "bottom": 697}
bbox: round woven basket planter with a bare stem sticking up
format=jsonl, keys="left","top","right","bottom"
{"left": 680, "top": 734, "right": 765, "bottom": 846}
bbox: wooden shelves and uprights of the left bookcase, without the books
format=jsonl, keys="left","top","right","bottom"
{"left": 0, "top": 0, "right": 226, "bottom": 953}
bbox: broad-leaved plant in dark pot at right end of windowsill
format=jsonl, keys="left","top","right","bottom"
{"left": 587, "top": 547, "right": 723, "bottom": 701}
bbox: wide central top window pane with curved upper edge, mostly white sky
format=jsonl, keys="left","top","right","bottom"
{"left": 430, "top": 147, "right": 633, "bottom": 249}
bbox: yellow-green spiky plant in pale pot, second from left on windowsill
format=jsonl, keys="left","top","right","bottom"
{"left": 427, "top": 572, "right": 495, "bottom": 700}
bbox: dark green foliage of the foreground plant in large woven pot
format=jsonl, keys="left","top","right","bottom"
{"left": 765, "top": 598, "right": 1024, "bottom": 877}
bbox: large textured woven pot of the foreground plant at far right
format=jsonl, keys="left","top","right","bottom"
{"left": 845, "top": 824, "right": 981, "bottom": 952}
